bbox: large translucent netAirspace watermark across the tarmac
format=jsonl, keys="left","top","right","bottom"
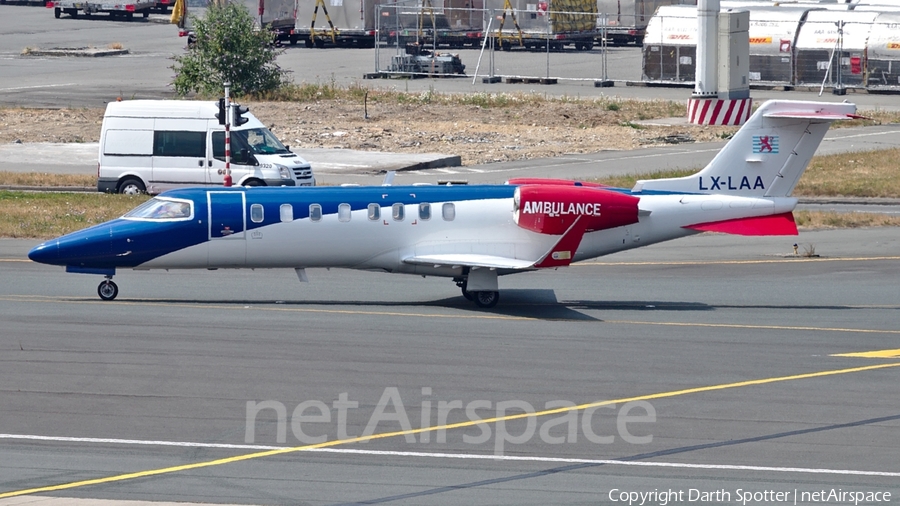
{"left": 244, "top": 387, "right": 656, "bottom": 455}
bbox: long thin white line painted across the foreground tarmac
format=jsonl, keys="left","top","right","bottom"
{"left": 0, "top": 434, "right": 900, "bottom": 478}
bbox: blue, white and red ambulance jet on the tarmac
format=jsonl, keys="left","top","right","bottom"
{"left": 28, "top": 101, "right": 858, "bottom": 308}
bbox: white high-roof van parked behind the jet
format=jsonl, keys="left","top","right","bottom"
{"left": 97, "top": 100, "right": 316, "bottom": 193}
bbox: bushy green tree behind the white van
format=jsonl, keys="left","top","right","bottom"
{"left": 171, "top": 2, "right": 287, "bottom": 96}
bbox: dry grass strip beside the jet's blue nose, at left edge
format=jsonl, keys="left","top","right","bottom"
{"left": 0, "top": 190, "right": 149, "bottom": 239}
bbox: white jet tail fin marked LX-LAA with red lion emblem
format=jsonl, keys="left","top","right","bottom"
{"left": 633, "top": 100, "right": 860, "bottom": 197}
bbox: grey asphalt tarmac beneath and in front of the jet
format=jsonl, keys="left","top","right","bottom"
{"left": 0, "top": 228, "right": 900, "bottom": 506}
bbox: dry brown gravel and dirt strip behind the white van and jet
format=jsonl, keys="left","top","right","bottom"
{"left": 0, "top": 100, "right": 734, "bottom": 165}
